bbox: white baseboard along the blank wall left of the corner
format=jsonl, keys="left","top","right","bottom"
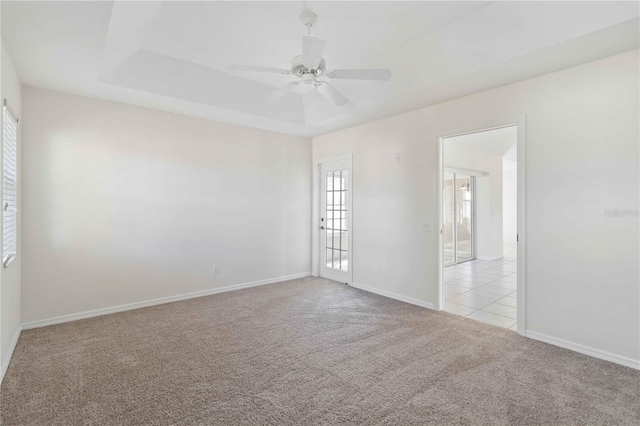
{"left": 22, "top": 272, "right": 311, "bottom": 330}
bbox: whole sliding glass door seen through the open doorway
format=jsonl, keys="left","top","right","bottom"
{"left": 442, "top": 172, "right": 475, "bottom": 266}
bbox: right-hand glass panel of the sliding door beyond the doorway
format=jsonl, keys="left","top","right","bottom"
{"left": 455, "top": 174, "right": 473, "bottom": 262}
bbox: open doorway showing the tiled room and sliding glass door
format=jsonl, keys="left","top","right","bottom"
{"left": 441, "top": 124, "right": 524, "bottom": 330}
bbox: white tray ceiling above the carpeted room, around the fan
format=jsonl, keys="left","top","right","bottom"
{"left": 2, "top": 0, "right": 639, "bottom": 136}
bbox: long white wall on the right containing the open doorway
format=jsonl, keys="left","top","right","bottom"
{"left": 313, "top": 50, "right": 640, "bottom": 367}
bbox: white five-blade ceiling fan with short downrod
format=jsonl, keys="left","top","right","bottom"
{"left": 229, "top": 12, "right": 391, "bottom": 106}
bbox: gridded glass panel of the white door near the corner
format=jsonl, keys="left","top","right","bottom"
{"left": 325, "top": 170, "right": 349, "bottom": 272}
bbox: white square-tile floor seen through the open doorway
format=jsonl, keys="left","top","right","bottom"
{"left": 444, "top": 259, "right": 518, "bottom": 330}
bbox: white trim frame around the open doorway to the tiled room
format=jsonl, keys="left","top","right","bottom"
{"left": 437, "top": 115, "right": 527, "bottom": 336}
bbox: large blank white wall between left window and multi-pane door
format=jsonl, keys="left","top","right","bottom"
{"left": 22, "top": 87, "right": 311, "bottom": 323}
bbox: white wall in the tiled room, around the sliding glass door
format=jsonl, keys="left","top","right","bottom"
{"left": 436, "top": 140, "right": 503, "bottom": 260}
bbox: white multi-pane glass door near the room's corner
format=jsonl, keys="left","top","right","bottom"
{"left": 319, "top": 160, "right": 353, "bottom": 284}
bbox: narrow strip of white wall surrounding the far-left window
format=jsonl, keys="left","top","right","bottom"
{"left": 0, "top": 44, "right": 22, "bottom": 377}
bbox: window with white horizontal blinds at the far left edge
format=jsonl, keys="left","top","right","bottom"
{"left": 2, "top": 99, "right": 18, "bottom": 268}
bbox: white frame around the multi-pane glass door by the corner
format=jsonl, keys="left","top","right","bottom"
{"left": 311, "top": 154, "right": 355, "bottom": 285}
